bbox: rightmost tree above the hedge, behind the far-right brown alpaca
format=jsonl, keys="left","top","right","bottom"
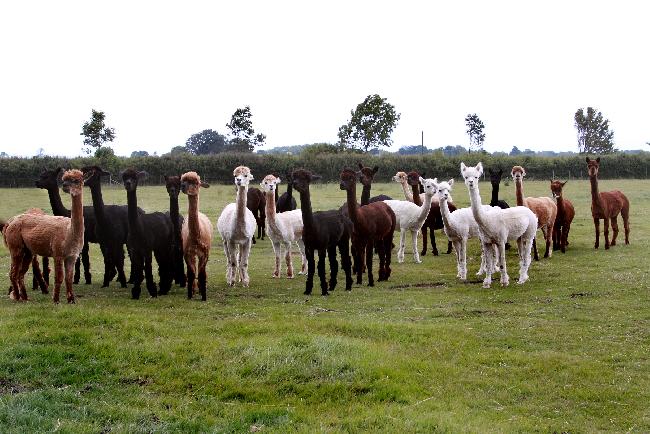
{"left": 573, "top": 107, "right": 616, "bottom": 154}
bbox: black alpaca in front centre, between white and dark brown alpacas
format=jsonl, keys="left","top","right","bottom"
{"left": 291, "top": 169, "right": 352, "bottom": 295}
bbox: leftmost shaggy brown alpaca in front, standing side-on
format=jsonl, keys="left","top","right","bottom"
{"left": 4, "top": 170, "right": 84, "bottom": 303}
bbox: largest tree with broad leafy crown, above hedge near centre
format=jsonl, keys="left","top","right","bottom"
{"left": 338, "top": 94, "right": 400, "bottom": 152}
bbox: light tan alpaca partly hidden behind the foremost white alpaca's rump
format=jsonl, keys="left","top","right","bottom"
{"left": 510, "top": 166, "right": 557, "bottom": 261}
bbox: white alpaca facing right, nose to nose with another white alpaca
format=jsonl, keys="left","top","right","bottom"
{"left": 384, "top": 178, "right": 437, "bottom": 264}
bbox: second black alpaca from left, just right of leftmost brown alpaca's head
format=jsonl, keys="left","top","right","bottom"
{"left": 81, "top": 166, "right": 139, "bottom": 288}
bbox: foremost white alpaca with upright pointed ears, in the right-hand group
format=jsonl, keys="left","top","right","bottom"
{"left": 460, "top": 163, "right": 537, "bottom": 288}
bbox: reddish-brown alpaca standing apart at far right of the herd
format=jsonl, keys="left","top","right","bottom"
{"left": 587, "top": 157, "right": 630, "bottom": 249}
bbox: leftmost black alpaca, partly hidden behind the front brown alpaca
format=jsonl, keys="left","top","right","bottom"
{"left": 35, "top": 167, "right": 99, "bottom": 289}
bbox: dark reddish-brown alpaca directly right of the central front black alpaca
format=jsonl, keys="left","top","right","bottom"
{"left": 340, "top": 169, "right": 395, "bottom": 286}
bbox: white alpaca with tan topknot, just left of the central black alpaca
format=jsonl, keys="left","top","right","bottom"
{"left": 260, "top": 175, "right": 307, "bottom": 279}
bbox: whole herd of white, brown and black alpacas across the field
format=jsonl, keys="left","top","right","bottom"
{"left": 0, "top": 157, "right": 630, "bottom": 303}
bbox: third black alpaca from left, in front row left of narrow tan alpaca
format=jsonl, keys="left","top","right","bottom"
{"left": 122, "top": 169, "right": 174, "bottom": 299}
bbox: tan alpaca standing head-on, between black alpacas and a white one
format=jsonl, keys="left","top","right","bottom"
{"left": 181, "top": 172, "right": 212, "bottom": 301}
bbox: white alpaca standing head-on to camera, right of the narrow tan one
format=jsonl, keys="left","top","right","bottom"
{"left": 217, "top": 166, "right": 256, "bottom": 286}
